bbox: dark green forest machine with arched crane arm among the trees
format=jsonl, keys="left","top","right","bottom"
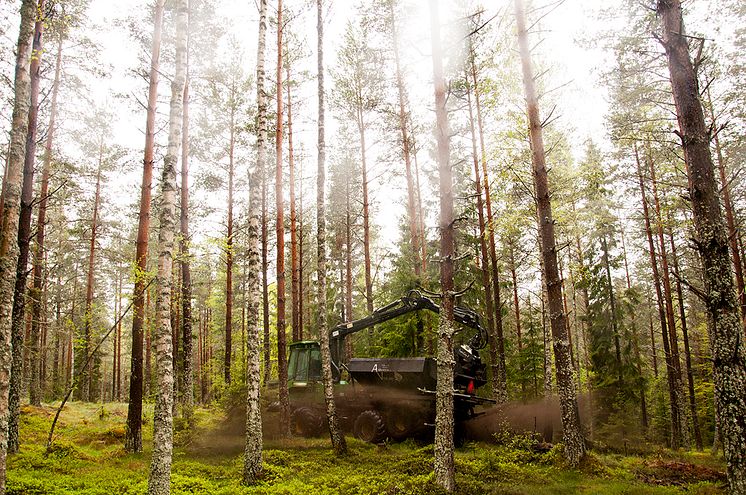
{"left": 288, "top": 291, "right": 495, "bottom": 443}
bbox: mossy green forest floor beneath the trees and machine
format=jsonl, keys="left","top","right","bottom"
{"left": 8, "top": 403, "right": 725, "bottom": 495}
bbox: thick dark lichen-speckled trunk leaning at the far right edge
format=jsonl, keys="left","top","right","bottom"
{"left": 657, "top": 0, "right": 746, "bottom": 494}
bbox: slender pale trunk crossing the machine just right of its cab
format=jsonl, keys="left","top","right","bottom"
{"left": 316, "top": 0, "right": 347, "bottom": 456}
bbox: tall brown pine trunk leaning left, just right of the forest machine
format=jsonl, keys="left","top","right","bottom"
{"left": 515, "top": 0, "right": 585, "bottom": 466}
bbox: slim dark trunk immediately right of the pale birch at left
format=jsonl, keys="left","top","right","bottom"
{"left": 179, "top": 32, "right": 194, "bottom": 422}
